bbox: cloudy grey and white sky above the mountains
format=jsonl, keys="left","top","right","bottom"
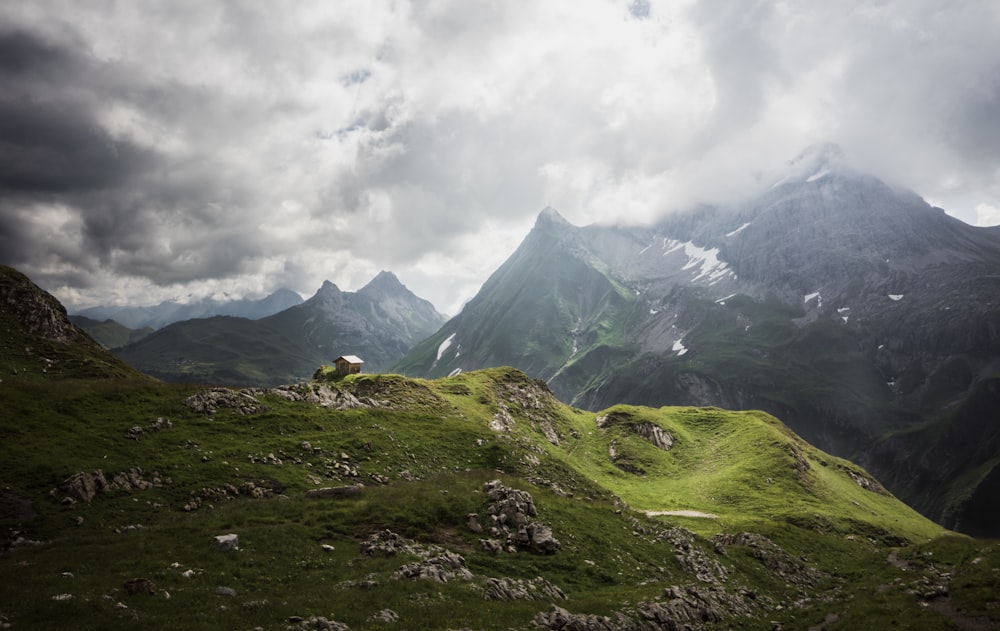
{"left": 0, "top": 0, "right": 1000, "bottom": 314}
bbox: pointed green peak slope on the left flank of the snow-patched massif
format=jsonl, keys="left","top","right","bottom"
{"left": 393, "top": 209, "right": 634, "bottom": 387}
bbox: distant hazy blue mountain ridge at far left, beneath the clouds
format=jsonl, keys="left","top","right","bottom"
{"left": 74, "top": 289, "right": 302, "bottom": 329}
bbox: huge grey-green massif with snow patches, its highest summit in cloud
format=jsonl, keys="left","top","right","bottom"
{"left": 396, "top": 145, "right": 1000, "bottom": 536}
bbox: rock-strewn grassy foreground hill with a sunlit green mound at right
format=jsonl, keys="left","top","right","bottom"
{"left": 0, "top": 368, "right": 1000, "bottom": 630}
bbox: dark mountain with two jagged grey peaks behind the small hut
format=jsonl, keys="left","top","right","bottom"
{"left": 114, "top": 271, "right": 445, "bottom": 385}
